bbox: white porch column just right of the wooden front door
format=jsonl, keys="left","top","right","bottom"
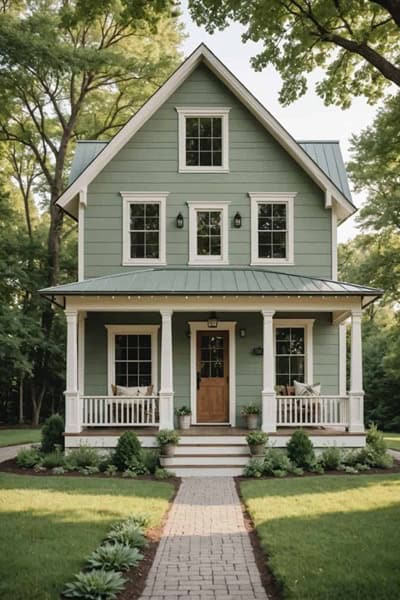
{"left": 261, "top": 310, "right": 276, "bottom": 432}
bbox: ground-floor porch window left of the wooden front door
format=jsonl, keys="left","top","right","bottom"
{"left": 106, "top": 325, "right": 159, "bottom": 393}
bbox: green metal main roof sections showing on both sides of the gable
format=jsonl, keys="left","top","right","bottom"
{"left": 68, "top": 140, "right": 352, "bottom": 202}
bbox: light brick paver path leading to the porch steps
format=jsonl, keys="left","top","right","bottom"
{"left": 141, "top": 477, "right": 268, "bottom": 600}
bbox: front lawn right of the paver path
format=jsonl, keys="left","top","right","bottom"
{"left": 241, "top": 474, "right": 400, "bottom": 600}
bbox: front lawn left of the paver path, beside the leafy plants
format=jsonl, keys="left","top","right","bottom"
{"left": 0, "top": 473, "right": 174, "bottom": 600}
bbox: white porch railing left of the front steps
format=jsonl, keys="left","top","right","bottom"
{"left": 82, "top": 396, "right": 159, "bottom": 427}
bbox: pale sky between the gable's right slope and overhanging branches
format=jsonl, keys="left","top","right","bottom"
{"left": 182, "top": 0, "right": 376, "bottom": 242}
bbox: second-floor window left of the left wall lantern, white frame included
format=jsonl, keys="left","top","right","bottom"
{"left": 121, "top": 192, "right": 168, "bottom": 265}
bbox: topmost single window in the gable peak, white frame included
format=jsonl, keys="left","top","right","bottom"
{"left": 176, "top": 107, "right": 229, "bottom": 173}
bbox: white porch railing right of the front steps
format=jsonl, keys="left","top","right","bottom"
{"left": 276, "top": 396, "right": 349, "bottom": 427}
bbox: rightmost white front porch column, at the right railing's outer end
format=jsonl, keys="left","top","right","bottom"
{"left": 349, "top": 310, "right": 364, "bottom": 433}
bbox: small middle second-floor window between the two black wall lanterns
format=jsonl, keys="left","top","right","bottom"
{"left": 188, "top": 202, "right": 229, "bottom": 265}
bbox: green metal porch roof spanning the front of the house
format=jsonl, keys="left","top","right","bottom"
{"left": 40, "top": 267, "right": 382, "bottom": 296}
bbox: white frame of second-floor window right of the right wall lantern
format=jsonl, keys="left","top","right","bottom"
{"left": 249, "top": 192, "right": 296, "bottom": 265}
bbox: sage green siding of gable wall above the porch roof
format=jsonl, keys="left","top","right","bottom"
{"left": 85, "top": 65, "right": 332, "bottom": 278}
